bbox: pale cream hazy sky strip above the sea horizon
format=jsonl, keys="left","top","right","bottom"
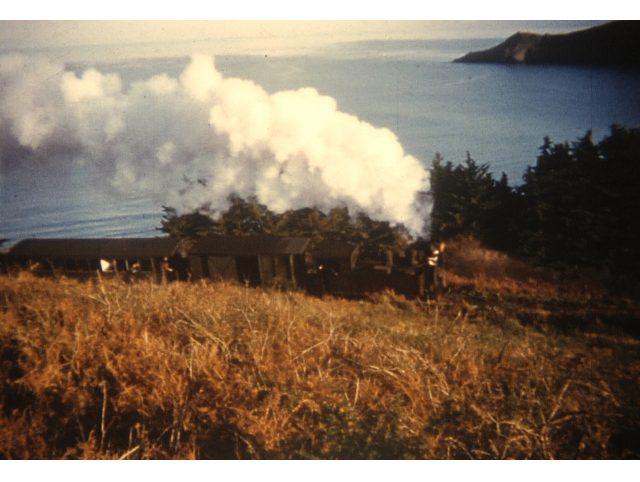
{"left": 0, "top": 20, "right": 608, "bottom": 48}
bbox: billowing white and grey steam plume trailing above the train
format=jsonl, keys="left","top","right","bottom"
{"left": 0, "top": 55, "right": 429, "bottom": 233}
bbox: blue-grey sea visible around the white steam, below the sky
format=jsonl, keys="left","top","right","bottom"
{"left": 0, "top": 38, "right": 640, "bottom": 244}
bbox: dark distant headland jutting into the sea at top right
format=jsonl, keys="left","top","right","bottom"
{"left": 454, "top": 20, "right": 640, "bottom": 66}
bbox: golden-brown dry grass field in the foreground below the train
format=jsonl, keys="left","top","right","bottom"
{"left": 0, "top": 252, "right": 640, "bottom": 459}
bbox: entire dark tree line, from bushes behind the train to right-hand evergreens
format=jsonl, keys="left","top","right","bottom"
{"left": 159, "top": 125, "right": 640, "bottom": 274}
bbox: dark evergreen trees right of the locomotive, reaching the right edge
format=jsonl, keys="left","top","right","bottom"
{"left": 430, "top": 125, "right": 640, "bottom": 275}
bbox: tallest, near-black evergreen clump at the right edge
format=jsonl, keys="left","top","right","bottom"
{"left": 519, "top": 126, "right": 640, "bottom": 272}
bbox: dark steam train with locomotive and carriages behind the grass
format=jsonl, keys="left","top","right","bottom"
{"left": 0, "top": 235, "right": 437, "bottom": 297}
